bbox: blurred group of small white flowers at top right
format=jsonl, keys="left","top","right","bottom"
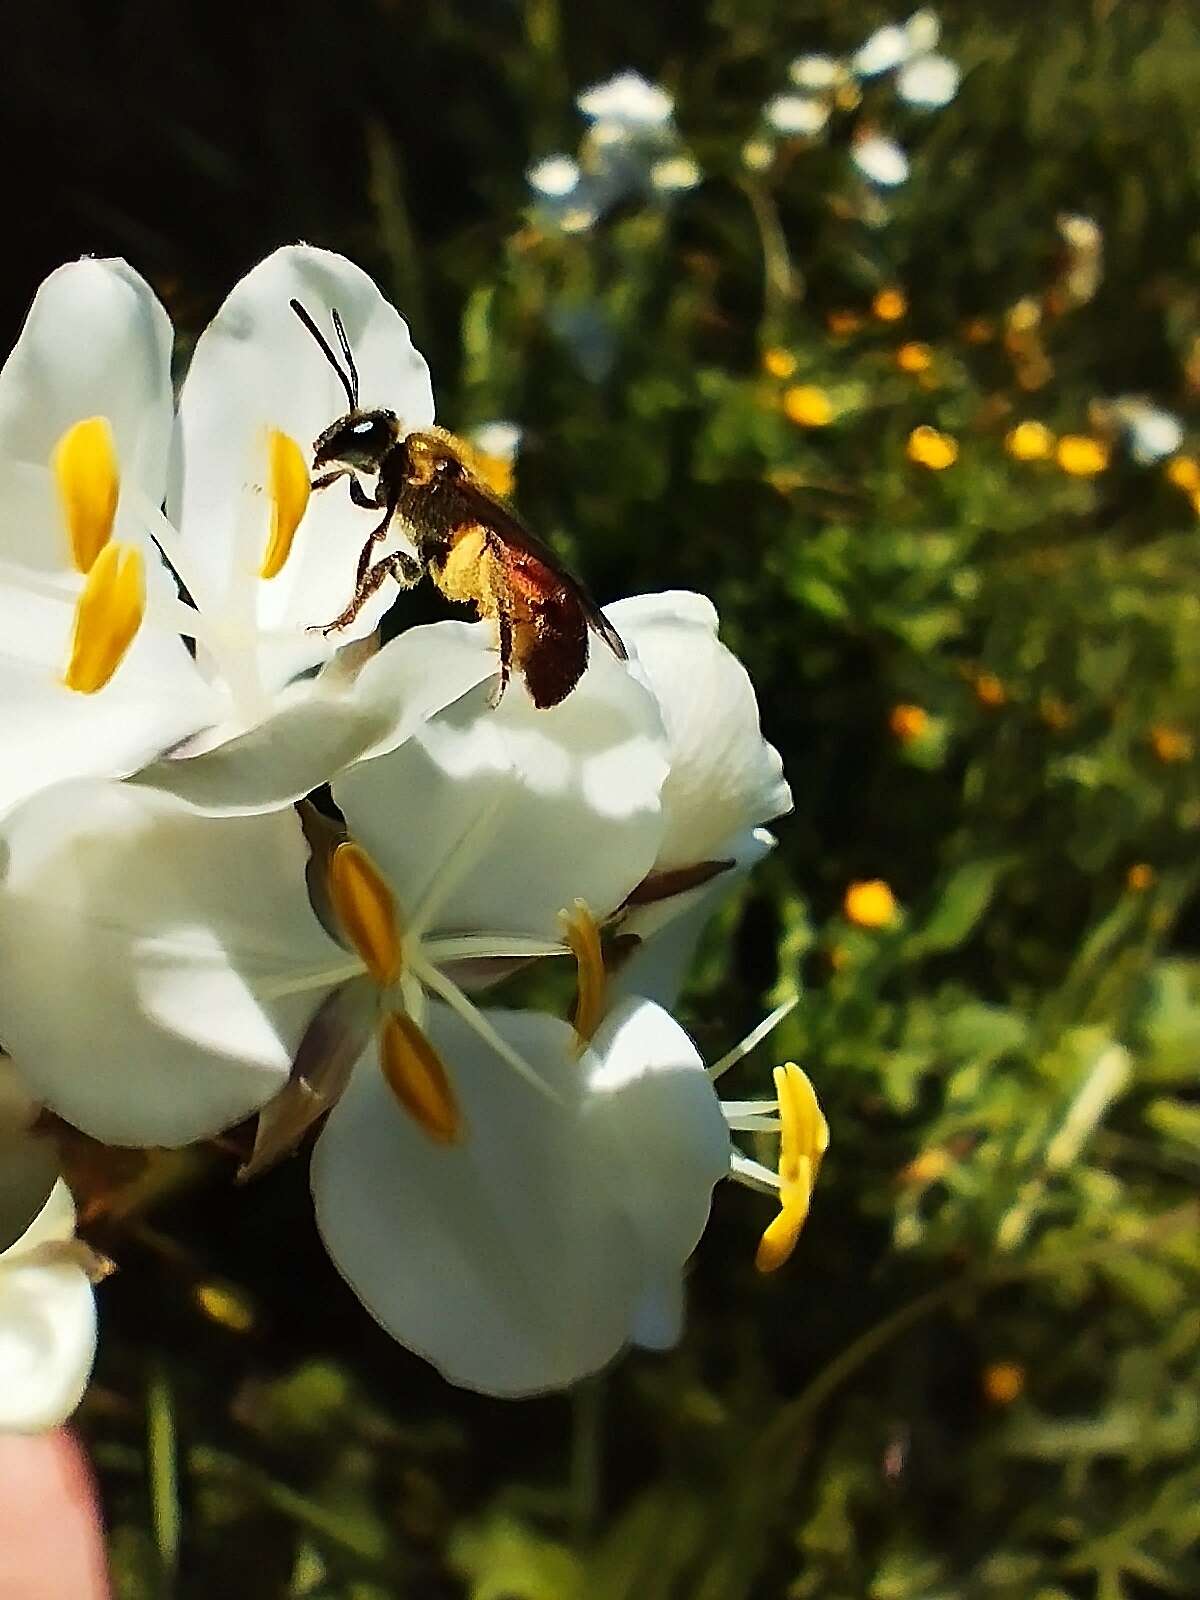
{"left": 746, "top": 8, "right": 960, "bottom": 221}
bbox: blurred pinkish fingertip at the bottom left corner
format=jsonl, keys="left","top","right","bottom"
{"left": 0, "top": 1429, "right": 112, "bottom": 1600}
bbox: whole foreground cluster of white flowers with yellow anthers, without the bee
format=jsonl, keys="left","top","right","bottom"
{"left": 0, "top": 246, "right": 809, "bottom": 1429}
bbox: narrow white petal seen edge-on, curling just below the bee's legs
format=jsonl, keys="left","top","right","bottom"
{"left": 128, "top": 622, "right": 496, "bottom": 816}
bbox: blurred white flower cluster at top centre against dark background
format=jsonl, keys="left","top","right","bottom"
{"left": 526, "top": 72, "right": 702, "bottom": 234}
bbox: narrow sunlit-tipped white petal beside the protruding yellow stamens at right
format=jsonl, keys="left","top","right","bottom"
{"left": 584, "top": 997, "right": 730, "bottom": 1277}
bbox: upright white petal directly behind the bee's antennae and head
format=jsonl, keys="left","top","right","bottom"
{"left": 173, "top": 245, "right": 434, "bottom": 685}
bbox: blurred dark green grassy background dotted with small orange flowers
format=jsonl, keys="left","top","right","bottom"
{"left": 47, "top": 0, "right": 1200, "bottom": 1600}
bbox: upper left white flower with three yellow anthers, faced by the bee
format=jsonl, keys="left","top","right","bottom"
{"left": 0, "top": 246, "right": 432, "bottom": 810}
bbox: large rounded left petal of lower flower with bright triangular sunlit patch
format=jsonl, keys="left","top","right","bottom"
{"left": 0, "top": 782, "right": 346, "bottom": 1144}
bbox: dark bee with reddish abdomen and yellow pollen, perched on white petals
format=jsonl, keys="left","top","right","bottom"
{"left": 290, "top": 299, "right": 627, "bottom": 710}
